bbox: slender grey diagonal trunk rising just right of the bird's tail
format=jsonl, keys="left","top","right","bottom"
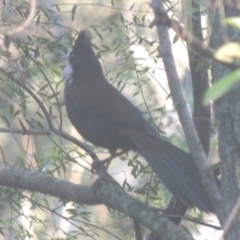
{"left": 152, "top": 0, "right": 221, "bottom": 215}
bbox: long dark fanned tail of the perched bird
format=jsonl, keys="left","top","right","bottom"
{"left": 129, "top": 131, "right": 213, "bottom": 212}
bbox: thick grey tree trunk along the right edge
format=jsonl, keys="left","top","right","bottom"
{"left": 209, "top": 1, "right": 240, "bottom": 240}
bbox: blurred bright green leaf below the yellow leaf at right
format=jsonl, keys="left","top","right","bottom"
{"left": 203, "top": 69, "right": 240, "bottom": 105}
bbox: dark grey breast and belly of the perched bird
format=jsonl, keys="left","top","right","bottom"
{"left": 65, "top": 91, "right": 133, "bottom": 152}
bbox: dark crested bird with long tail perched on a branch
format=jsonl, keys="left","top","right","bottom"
{"left": 63, "top": 30, "right": 214, "bottom": 212}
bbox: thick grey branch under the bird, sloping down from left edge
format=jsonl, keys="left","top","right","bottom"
{"left": 0, "top": 168, "right": 193, "bottom": 240}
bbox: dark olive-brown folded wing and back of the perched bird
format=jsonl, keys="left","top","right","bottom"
{"left": 65, "top": 81, "right": 156, "bottom": 136}
